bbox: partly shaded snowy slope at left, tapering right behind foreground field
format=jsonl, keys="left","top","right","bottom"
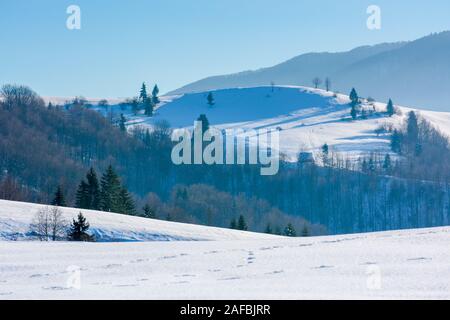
{"left": 0, "top": 200, "right": 275, "bottom": 242}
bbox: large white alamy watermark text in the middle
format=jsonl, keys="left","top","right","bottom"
{"left": 171, "top": 121, "right": 280, "bottom": 176}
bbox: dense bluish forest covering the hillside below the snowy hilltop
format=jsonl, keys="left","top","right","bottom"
{"left": 0, "top": 86, "right": 450, "bottom": 235}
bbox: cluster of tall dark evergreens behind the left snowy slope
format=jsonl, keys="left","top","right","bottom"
{"left": 75, "top": 165, "right": 136, "bottom": 215}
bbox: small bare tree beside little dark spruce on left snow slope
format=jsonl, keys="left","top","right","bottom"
{"left": 30, "top": 207, "right": 67, "bottom": 241}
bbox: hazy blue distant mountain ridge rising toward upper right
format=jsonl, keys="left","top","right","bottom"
{"left": 169, "top": 31, "right": 450, "bottom": 111}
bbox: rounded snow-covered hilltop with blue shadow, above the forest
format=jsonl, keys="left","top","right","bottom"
{"left": 127, "top": 86, "right": 450, "bottom": 160}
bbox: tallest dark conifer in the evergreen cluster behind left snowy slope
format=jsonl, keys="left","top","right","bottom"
{"left": 100, "top": 165, "right": 122, "bottom": 212}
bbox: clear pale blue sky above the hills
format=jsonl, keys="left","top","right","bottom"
{"left": 0, "top": 0, "right": 450, "bottom": 97}
